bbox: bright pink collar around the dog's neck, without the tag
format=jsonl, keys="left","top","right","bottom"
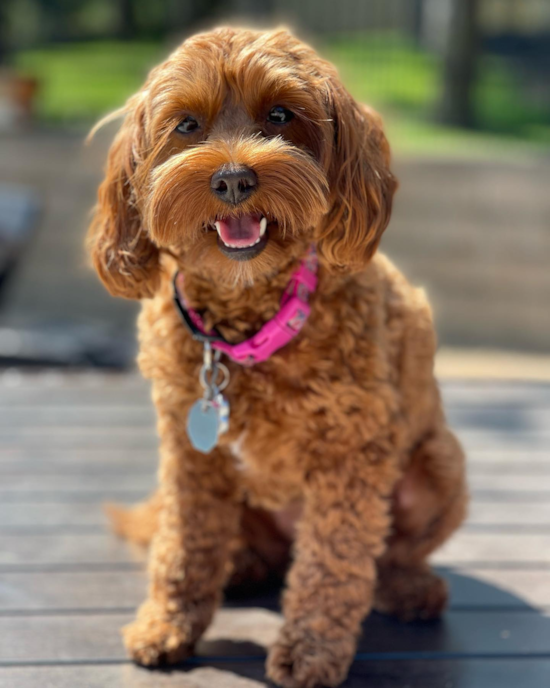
{"left": 174, "top": 244, "right": 317, "bottom": 366}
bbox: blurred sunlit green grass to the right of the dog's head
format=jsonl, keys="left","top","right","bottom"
{"left": 324, "top": 34, "right": 550, "bottom": 156}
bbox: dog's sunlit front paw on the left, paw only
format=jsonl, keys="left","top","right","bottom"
{"left": 122, "top": 601, "right": 194, "bottom": 666}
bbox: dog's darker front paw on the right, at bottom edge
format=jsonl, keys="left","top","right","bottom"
{"left": 267, "top": 624, "right": 356, "bottom": 688}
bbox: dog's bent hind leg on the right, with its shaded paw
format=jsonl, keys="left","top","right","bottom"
{"left": 374, "top": 426, "right": 467, "bottom": 621}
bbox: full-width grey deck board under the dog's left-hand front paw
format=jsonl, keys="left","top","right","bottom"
{"left": 0, "top": 608, "right": 550, "bottom": 667}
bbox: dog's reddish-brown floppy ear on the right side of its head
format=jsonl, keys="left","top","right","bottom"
{"left": 317, "top": 79, "right": 397, "bottom": 271}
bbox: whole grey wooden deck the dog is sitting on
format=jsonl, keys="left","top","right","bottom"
{"left": 0, "top": 371, "right": 550, "bottom": 688}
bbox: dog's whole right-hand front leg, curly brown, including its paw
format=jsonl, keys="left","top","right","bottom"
{"left": 267, "top": 442, "right": 398, "bottom": 688}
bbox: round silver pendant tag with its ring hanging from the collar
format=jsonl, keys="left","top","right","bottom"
{"left": 187, "top": 342, "right": 229, "bottom": 454}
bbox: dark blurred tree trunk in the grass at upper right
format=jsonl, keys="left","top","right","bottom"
{"left": 439, "top": 0, "right": 478, "bottom": 127}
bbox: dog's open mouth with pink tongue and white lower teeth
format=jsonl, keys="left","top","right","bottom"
{"left": 214, "top": 213, "right": 269, "bottom": 260}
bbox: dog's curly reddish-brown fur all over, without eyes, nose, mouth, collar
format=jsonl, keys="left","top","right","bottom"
{"left": 89, "top": 29, "right": 466, "bottom": 688}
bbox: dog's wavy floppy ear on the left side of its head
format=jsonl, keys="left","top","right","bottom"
{"left": 88, "top": 94, "right": 160, "bottom": 299}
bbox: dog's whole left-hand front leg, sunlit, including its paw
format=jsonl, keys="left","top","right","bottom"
{"left": 123, "top": 413, "right": 239, "bottom": 665}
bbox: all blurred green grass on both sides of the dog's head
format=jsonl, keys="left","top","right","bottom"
{"left": 16, "top": 34, "right": 550, "bottom": 156}
